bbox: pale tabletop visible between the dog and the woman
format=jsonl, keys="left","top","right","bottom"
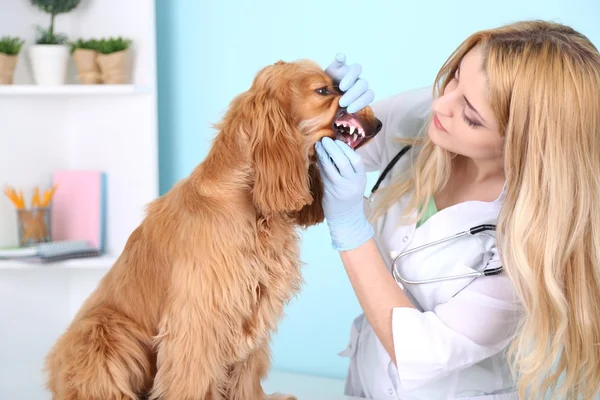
{"left": 263, "top": 370, "right": 361, "bottom": 400}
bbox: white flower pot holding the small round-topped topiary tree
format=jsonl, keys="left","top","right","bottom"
{"left": 29, "top": 44, "right": 70, "bottom": 85}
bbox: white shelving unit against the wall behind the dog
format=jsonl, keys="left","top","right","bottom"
{"left": 0, "top": 0, "right": 159, "bottom": 400}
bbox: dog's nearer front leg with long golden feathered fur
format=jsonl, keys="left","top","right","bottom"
{"left": 148, "top": 268, "right": 231, "bottom": 400}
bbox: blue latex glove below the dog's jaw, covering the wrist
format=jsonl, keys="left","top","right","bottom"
{"left": 315, "top": 137, "right": 373, "bottom": 250}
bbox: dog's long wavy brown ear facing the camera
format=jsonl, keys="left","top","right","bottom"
{"left": 249, "top": 75, "right": 312, "bottom": 215}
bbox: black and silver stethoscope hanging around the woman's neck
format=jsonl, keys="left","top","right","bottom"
{"left": 365, "top": 145, "right": 503, "bottom": 285}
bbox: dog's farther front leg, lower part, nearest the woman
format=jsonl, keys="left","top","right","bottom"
{"left": 227, "top": 341, "right": 296, "bottom": 400}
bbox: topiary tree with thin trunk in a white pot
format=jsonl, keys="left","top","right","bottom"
{"left": 29, "top": 0, "right": 80, "bottom": 85}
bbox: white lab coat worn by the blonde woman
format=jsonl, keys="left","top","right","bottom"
{"left": 340, "top": 88, "right": 520, "bottom": 400}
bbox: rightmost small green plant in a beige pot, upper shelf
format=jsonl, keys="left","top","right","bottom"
{"left": 98, "top": 37, "right": 132, "bottom": 84}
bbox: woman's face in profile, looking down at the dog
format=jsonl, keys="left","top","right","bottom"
{"left": 428, "top": 47, "right": 503, "bottom": 161}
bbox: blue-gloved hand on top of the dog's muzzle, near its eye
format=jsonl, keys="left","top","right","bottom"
{"left": 325, "top": 53, "right": 375, "bottom": 113}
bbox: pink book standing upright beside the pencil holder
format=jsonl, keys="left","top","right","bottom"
{"left": 51, "top": 170, "right": 106, "bottom": 251}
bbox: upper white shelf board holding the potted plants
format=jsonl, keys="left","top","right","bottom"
{"left": 0, "top": 84, "right": 151, "bottom": 96}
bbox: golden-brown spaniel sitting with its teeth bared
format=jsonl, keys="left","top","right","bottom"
{"left": 46, "top": 61, "right": 381, "bottom": 400}
